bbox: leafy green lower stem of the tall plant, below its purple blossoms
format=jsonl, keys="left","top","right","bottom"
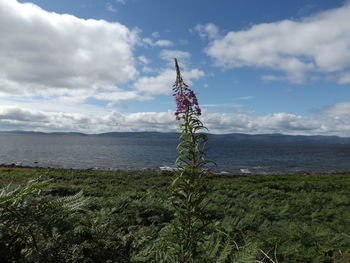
{"left": 165, "top": 117, "right": 211, "bottom": 263}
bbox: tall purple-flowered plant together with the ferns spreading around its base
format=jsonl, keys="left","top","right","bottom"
{"left": 141, "top": 59, "right": 260, "bottom": 263}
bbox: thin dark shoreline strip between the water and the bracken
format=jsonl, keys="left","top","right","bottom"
{"left": 0, "top": 163, "right": 350, "bottom": 176}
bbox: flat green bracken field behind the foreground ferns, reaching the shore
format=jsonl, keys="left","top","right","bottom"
{"left": 0, "top": 167, "right": 350, "bottom": 263}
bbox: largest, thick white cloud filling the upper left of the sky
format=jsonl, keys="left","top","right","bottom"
{"left": 0, "top": 0, "right": 137, "bottom": 103}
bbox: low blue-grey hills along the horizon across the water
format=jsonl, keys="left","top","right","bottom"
{"left": 0, "top": 131, "right": 350, "bottom": 144}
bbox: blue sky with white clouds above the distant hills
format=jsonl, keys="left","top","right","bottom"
{"left": 0, "top": 0, "right": 350, "bottom": 137}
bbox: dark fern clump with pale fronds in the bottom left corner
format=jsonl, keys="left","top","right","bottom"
{"left": 0, "top": 177, "right": 130, "bottom": 263}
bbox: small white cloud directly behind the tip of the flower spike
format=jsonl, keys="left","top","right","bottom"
{"left": 134, "top": 69, "right": 204, "bottom": 95}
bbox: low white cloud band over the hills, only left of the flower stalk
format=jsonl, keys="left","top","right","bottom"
{"left": 0, "top": 106, "right": 178, "bottom": 133}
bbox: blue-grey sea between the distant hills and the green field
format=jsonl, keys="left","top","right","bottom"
{"left": 0, "top": 135, "right": 350, "bottom": 173}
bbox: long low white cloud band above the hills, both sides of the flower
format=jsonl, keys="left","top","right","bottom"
{"left": 0, "top": 103, "right": 350, "bottom": 136}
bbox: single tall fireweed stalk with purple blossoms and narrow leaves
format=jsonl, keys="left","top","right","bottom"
{"left": 169, "top": 59, "right": 210, "bottom": 263}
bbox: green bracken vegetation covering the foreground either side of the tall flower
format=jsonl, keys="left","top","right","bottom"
{"left": 0, "top": 168, "right": 350, "bottom": 263}
